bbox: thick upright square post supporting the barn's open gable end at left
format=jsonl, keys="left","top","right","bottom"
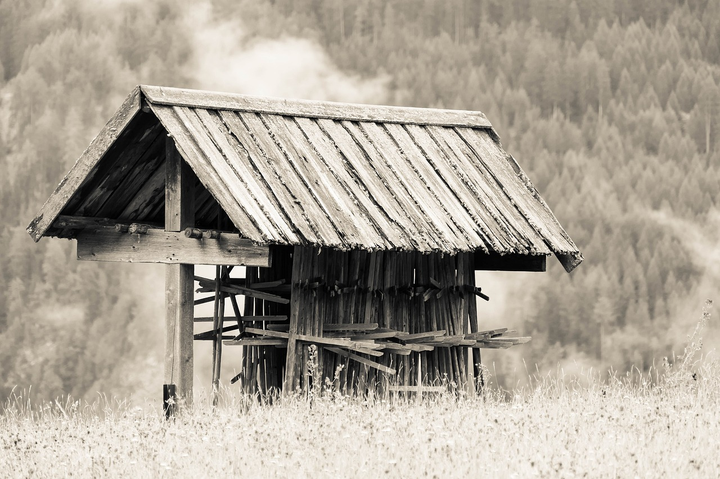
{"left": 165, "top": 137, "right": 195, "bottom": 406}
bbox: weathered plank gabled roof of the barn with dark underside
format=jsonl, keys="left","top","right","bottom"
{"left": 28, "top": 86, "right": 582, "bottom": 271}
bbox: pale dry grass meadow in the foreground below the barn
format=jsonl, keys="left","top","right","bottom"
{"left": 0, "top": 302, "right": 720, "bottom": 477}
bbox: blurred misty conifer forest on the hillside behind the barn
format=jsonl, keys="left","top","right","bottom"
{"left": 0, "top": 0, "right": 720, "bottom": 400}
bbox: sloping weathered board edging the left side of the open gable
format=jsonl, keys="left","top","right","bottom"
{"left": 27, "top": 87, "right": 141, "bottom": 242}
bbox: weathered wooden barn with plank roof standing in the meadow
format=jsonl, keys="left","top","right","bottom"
{"left": 28, "top": 86, "right": 582, "bottom": 406}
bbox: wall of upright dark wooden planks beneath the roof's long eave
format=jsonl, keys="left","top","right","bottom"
{"left": 272, "top": 247, "right": 479, "bottom": 394}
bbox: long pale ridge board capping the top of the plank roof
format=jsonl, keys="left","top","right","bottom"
{"left": 140, "top": 85, "right": 492, "bottom": 128}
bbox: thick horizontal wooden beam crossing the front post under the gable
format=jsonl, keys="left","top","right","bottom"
{"left": 77, "top": 227, "right": 272, "bottom": 268}
